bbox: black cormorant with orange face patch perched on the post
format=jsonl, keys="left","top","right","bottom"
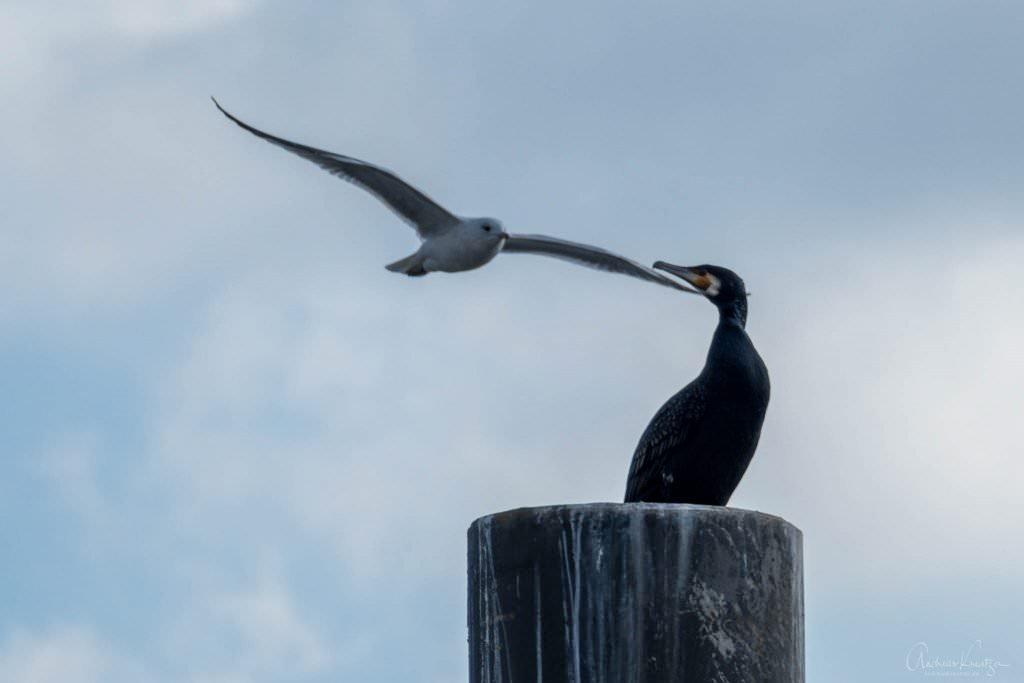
{"left": 626, "top": 261, "right": 769, "bottom": 505}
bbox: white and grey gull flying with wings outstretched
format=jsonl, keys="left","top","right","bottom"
{"left": 211, "top": 97, "right": 697, "bottom": 294}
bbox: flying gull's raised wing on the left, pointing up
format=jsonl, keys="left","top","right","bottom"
{"left": 210, "top": 97, "right": 459, "bottom": 240}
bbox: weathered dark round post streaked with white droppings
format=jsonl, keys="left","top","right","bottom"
{"left": 469, "top": 503, "right": 804, "bottom": 683}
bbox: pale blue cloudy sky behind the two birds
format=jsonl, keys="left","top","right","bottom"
{"left": 0, "top": 0, "right": 1024, "bottom": 683}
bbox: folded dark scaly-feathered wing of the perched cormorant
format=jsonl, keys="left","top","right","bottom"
{"left": 624, "top": 383, "right": 705, "bottom": 503}
